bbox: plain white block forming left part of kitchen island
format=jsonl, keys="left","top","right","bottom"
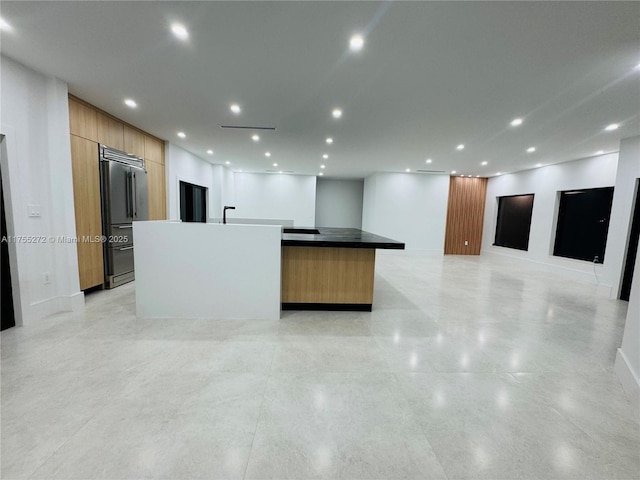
{"left": 133, "top": 221, "right": 282, "bottom": 320}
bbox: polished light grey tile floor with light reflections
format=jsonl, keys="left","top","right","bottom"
{"left": 1, "top": 252, "right": 640, "bottom": 480}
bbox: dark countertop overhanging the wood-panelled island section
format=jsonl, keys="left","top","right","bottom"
{"left": 282, "top": 227, "right": 404, "bottom": 250}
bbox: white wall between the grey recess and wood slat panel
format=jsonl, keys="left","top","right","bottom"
{"left": 362, "top": 173, "right": 449, "bottom": 253}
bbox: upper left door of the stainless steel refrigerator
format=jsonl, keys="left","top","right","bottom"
{"left": 102, "top": 162, "right": 133, "bottom": 224}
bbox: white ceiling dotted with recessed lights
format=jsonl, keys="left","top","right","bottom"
{"left": 0, "top": 0, "right": 640, "bottom": 178}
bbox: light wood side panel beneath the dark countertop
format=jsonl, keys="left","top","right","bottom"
{"left": 281, "top": 246, "right": 376, "bottom": 305}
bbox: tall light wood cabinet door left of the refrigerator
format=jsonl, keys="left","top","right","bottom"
{"left": 71, "top": 135, "right": 104, "bottom": 290}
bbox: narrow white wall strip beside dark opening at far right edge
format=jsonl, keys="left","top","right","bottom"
{"left": 604, "top": 136, "right": 640, "bottom": 298}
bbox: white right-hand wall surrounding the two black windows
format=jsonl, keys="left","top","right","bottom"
{"left": 482, "top": 153, "right": 618, "bottom": 287}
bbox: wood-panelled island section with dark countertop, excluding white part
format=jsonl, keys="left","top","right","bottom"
{"left": 281, "top": 227, "right": 405, "bottom": 312}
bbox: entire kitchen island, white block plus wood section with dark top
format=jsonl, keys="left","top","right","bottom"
{"left": 133, "top": 221, "right": 404, "bottom": 320}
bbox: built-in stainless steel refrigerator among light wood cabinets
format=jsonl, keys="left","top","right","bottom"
{"left": 100, "top": 145, "right": 149, "bottom": 288}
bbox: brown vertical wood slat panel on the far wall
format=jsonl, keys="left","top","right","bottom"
{"left": 444, "top": 177, "right": 487, "bottom": 255}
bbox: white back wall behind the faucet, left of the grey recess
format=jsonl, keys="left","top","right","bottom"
{"left": 231, "top": 173, "right": 316, "bottom": 227}
